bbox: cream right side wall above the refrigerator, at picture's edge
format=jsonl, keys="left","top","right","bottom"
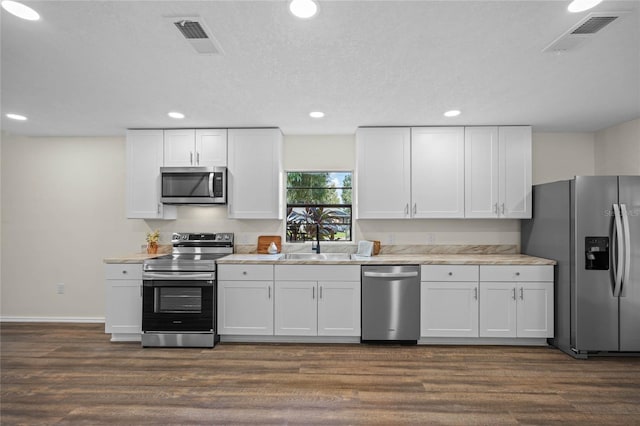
{"left": 595, "top": 118, "right": 640, "bottom": 175}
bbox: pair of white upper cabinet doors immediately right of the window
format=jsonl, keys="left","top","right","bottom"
{"left": 356, "top": 127, "right": 464, "bottom": 219}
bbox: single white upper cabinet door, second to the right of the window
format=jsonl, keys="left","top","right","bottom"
{"left": 411, "top": 127, "right": 464, "bottom": 219}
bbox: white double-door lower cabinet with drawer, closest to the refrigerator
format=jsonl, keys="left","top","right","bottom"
{"left": 480, "top": 265, "right": 554, "bottom": 338}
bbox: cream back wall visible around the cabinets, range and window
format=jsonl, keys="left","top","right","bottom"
{"left": 0, "top": 125, "right": 625, "bottom": 319}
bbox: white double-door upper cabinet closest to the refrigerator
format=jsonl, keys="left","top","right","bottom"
{"left": 464, "top": 126, "right": 531, "bottom": 219}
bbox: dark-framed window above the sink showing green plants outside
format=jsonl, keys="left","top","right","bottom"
{"left": 287, "top": 172, "right": 352, "bottom": 242}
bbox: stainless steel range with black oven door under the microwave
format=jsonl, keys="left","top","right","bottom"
{"left": 142, "top": 233, "right": 233, "bottom": 348}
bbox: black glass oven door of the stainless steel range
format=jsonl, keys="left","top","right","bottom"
{"left": 142, "top": 273, "right": 216, "bottom": 333}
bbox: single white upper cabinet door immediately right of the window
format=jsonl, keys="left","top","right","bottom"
{"left": 355, "top": 127, "right": 411, "bottom": 219}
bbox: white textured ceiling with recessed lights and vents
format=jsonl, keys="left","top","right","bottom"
{"left": 0, "top": 0, "right": 640, "bottom": 136}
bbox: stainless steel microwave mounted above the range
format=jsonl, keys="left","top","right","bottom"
{"left": 160, "top": 167, "right": 227, "bottom": 205}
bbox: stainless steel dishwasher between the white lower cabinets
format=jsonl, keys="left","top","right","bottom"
{"left": 361, "top": 265, "right": 420, "bottom": 343}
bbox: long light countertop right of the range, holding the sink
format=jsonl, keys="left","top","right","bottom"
{"left": 217, "top": 254, "right": 556, "bottom": 265}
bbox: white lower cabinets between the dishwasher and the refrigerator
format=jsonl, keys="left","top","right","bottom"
{"left": 420, "top": 265, "right": 554, "bottom": 338}
